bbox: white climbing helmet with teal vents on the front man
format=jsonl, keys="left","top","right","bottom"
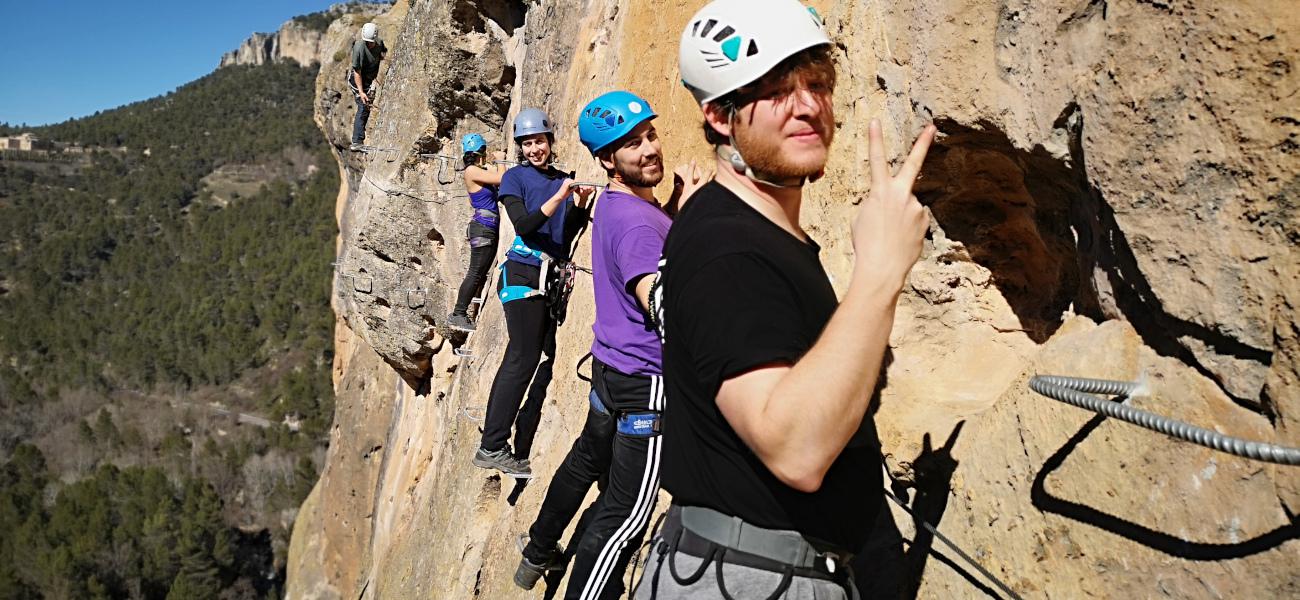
{"left": 677, "top": 0, "right": 831, "bottom": 105}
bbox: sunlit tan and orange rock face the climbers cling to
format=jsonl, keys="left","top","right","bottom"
{"left": 289, "top": 0, "right": 1300, "bottom": 599}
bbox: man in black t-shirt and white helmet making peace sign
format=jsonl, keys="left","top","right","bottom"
{"left": 636, "top": 0, "right": 935, "bottom": 600}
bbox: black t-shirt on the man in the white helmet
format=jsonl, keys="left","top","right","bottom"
{"left": 662, "top": 182, "right": 883, "bottom": 549}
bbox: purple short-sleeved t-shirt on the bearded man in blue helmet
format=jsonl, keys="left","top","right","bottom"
{"left": 592, "top": 190, "right": 672, "bottom": 375}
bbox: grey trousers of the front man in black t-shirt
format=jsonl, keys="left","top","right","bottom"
{"left": 633, "top": 536, "right": 849, "bottom": 600}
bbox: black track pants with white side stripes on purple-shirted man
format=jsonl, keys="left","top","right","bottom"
{"left": 524, "top": 360, "right": 664, "bottom": 600}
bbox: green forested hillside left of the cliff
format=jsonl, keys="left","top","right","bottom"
{"left": 0, "top": 59, "right": 338, "bottom": 599}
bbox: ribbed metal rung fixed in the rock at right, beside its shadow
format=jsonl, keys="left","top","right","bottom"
{"left": 1030, "top": 375, "right": 1300, "bottom": 465}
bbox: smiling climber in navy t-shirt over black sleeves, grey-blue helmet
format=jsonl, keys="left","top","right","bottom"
{"left": 473, "top": 108, "right": 594, "bottom": 478}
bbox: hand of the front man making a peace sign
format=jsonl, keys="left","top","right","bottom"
{"left": 853, "top": 119, "right": 937, "bottom": 288}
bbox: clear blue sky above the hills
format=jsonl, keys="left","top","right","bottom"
{"left": 0, "top": 0, "right": 339, "bottom": 125}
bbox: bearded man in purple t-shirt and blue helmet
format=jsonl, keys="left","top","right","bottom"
{"left": 515, "top": 91, "right": 699, "bottom": 599}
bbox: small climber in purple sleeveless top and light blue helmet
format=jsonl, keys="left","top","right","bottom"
{"left": 447, "top": 134, "right": 506, "bottom": 331}
